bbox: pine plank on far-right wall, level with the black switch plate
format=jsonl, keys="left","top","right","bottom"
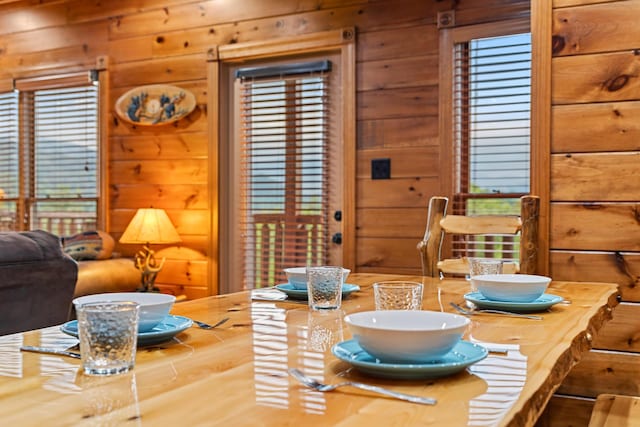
{"left": 551, "top": 152, "right": 640, "bottom": 201}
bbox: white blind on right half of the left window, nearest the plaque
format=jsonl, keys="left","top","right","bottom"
{"left": 28, "top": 85, "right": 98, "bottom": 234}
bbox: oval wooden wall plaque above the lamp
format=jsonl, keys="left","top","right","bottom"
{"left": 116, "top": 85, "right": 196, "bottom": 126}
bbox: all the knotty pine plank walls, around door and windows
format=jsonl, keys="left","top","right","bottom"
{"left": 0, "top": 0, "right": 640, "bottom": 425}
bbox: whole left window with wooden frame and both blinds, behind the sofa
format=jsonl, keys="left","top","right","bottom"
{"left": 0, "top": 73, "right": 98, "bottom": 235}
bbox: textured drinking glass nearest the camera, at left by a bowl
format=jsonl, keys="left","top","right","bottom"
{"left": 76, "top": 302, "right": 140, "bottom": 375}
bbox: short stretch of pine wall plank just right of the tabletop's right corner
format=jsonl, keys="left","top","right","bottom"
{"left": 593, "top": 302, "right": 640, "bottom": 353}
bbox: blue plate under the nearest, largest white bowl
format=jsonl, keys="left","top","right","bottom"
{"left": 331, "top": 340, "right": 489, "bottom": 380}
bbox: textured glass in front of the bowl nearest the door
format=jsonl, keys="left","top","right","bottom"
{"left": 307, "top": 266, "right": 342, "bottom": 310}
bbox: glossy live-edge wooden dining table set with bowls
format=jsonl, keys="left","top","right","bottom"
{"left": 0, "top": 274, "right": 618, "bottom": 427}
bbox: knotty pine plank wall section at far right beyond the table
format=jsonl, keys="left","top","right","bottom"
{"left": 539, "top": 0, "right": 640, "bottom": 426}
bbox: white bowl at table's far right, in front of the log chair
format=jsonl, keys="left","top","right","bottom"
{"left": 471, "top": 274, "right": 551, "bottom": 302}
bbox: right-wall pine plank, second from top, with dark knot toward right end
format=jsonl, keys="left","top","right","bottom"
{"left": 551, "top": 50, "right": 640, "bottom": 105}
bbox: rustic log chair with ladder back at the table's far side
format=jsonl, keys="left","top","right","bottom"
{"left": 417, "top": 195, "right": 540, "bottom": 277}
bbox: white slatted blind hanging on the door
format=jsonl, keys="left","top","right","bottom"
{"left": 239, "top": 61, "right": 331, "bottom": 288}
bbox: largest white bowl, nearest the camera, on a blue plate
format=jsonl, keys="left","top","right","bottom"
{"left": 344, "top": 310, "right": 470, "bottom": 363}
